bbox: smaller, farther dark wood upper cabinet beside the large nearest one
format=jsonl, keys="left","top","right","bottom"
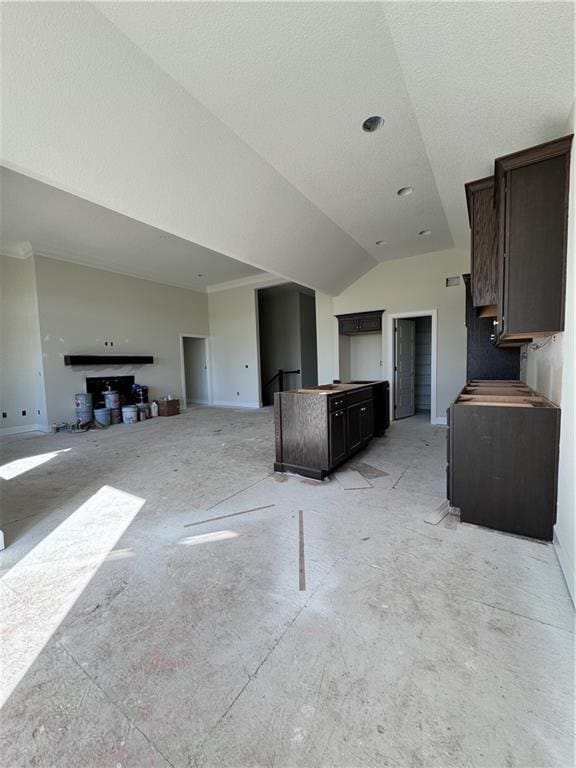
{"left": 465, "top": 176, "right": 498, "bottom": 314}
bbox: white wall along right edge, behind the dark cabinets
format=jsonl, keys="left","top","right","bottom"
{"left": 524, "top": 107, "right": 576, "bottom": 601}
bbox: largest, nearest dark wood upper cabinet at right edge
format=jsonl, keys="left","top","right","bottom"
{"left": 495, "top": 136, "right": 572, "bottom": 346}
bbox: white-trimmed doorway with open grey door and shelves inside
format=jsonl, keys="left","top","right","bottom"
{"left": 388, "top": 310, "right": 437, "bottom": 424}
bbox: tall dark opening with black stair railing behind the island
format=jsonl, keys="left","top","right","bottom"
{"left": 258, "top": 283, "right": 318, "bottom": 405}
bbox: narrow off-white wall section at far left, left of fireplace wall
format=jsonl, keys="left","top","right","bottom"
{"left": 0, "top": 256, "right": 47, "bottom": 433}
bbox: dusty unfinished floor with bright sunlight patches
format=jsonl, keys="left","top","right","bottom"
{"left": 0, "top": 408, "right": 574, "bottom": 768}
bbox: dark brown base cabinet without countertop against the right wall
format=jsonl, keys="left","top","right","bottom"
{"left": 447, "top": 380, "right": 560, "bottom": 541}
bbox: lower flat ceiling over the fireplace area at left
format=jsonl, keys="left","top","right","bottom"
{"left": 0, "top": 168, "right": 262, "bottom": 291}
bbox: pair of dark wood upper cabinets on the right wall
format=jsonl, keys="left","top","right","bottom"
{"left": 465, "top": 136, "right": 572, "bottom": 347}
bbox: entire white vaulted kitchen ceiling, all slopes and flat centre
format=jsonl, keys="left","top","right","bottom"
{"left": 3, "top": 2, "right": 574, "bottom": 293}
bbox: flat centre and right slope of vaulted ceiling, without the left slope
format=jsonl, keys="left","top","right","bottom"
{"left": 99, "top": 1, "right": 574, "bottom": 260}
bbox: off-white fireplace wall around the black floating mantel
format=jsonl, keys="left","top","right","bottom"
{"left": 35, "top": 256, "right": 208, "bottom": 423}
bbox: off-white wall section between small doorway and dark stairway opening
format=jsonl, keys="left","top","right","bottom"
{"left": 208, "top": 288, "right": 260, "bottom": 408}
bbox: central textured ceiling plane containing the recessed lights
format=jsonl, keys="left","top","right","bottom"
{"left": 98, "top": 2, "right": 452, "bottom": 260}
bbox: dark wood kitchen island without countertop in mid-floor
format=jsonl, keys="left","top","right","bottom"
{"left": 274, "top": 381, "right": 389, "bottom": 480}
